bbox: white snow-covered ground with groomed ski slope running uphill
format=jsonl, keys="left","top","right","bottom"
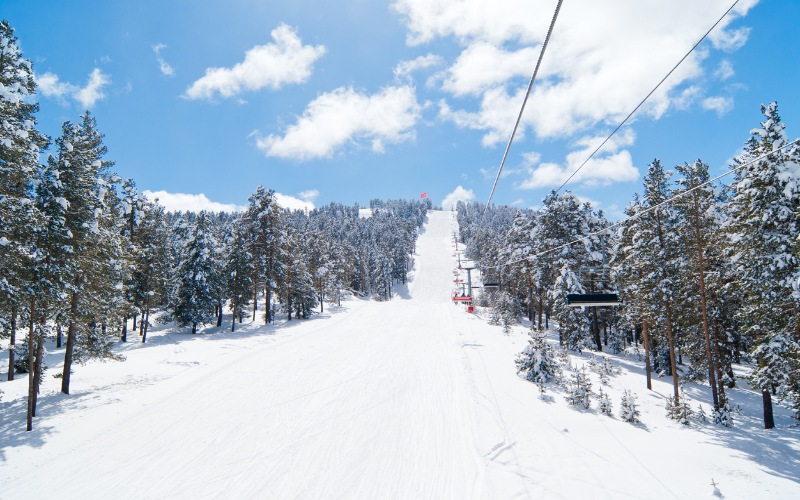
{"left": 0, "top": 212, "right": 800, "bottom": 499}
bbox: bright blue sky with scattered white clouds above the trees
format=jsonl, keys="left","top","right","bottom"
{"left": 0, "top": 0, "right": 800, "bottom": 218}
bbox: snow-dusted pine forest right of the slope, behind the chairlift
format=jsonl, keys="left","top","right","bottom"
{"left": 457, "top": 103, "right": 800, "bottom": 428}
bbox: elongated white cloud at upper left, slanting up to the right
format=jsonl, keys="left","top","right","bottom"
{"left": 184, "top": 24, "right": 326, "bottom": 99}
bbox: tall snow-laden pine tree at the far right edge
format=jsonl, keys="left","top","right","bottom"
{"left": 728, "top": 102, "right": 800, "bottom": 429}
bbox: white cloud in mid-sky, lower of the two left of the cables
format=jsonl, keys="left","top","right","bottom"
{"left": 256, "top": 86, "right": 421, "bottom": 160}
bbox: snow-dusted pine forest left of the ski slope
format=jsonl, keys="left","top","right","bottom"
{"left": 0, "top": 21, "right": 431, "bottom": 430}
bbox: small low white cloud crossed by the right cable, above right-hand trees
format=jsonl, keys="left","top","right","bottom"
{"left": 519, "top": 129, "right": 639, "bottom": 189}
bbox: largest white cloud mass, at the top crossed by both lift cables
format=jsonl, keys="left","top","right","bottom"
{"left": 393, "top": 0, "right": 757, "bottom": 147}
